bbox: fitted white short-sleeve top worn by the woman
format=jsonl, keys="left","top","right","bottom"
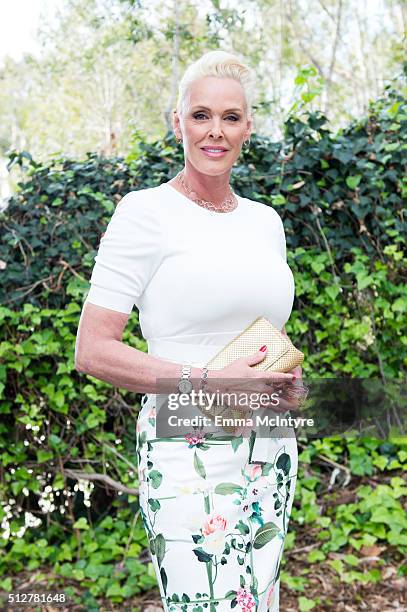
{"left": 86, "top": 183, "right": 295, "bottom": 341}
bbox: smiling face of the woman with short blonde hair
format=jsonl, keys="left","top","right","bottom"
{"left": 174, "top": 76, "right": 252, "bottom": 176}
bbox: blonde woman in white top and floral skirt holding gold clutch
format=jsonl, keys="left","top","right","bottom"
{"left": 76, "top": 51, "right": 301, "bottom": 611}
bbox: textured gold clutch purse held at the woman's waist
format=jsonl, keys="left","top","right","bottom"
{"left": 202, "top": 317, "right": 304, "bottom": 433}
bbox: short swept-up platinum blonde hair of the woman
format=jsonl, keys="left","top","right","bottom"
{"left": 177, "top": 50, "right": 253, "bottom": 117}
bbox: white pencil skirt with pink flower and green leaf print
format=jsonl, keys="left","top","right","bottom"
{"left": 137, "top": 395, "right": 298, "bottom": 612}
